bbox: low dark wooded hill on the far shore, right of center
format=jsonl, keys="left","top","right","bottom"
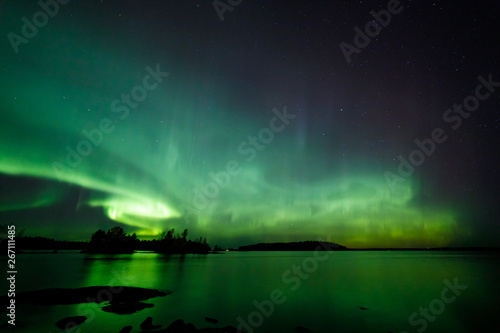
{"left": 238, "top": 241, "right": 347, "bottom": 251}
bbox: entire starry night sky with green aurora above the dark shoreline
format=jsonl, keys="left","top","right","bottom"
{"left": 0, "top": 0, "right": 500, "bottom": 247}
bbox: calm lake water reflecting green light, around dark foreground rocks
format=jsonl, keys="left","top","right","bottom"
{"left": 1, "top": 251, "right": 500, "bottom": 333}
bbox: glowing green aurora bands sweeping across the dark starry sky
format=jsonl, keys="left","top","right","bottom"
{"left": 0, "top": 3, "right": 496, "bottom": 247}
